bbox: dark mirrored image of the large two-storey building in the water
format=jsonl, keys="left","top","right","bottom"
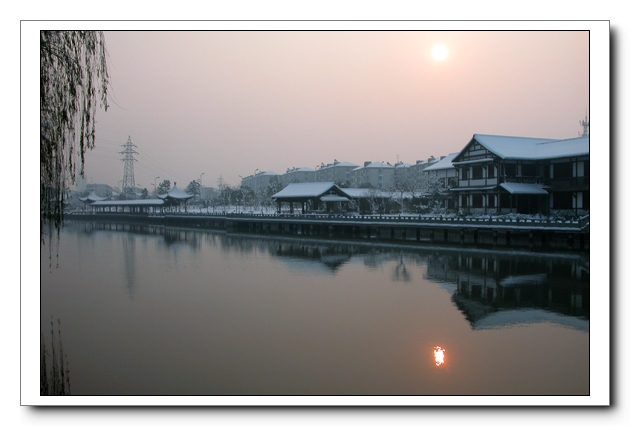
{"left": 427, "top": 253, "right": 590, "bottom": 330}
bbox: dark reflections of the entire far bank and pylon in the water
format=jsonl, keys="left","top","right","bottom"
{"left": 69, "top": 222, "right": 590, "bottom": 331}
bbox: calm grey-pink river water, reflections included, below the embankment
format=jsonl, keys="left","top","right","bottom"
{"left": 41, "top": 222, "right": 590, "bottom": 395}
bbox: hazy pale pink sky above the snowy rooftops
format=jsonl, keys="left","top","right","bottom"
{"left": 86, "top": 31, "right": 589, "bottom": 190}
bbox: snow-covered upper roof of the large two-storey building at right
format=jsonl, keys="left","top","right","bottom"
{"left": 474, "top": 134, "right": 590, "bottom": 160}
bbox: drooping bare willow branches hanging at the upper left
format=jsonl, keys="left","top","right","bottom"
{"left": 40, "top": 31, "right": 109, "bottom": 241}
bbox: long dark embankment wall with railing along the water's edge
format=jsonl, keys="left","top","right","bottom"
{"left": 66, "top": 212, "right": 590, "bottom": 253}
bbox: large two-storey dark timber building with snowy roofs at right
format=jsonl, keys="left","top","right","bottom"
{"left": 450, "top": 134, "right": 590, "bottom": 215}
